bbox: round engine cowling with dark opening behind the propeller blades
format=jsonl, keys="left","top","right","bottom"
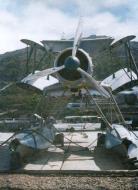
{"left": 54, "top": 48, "right": 93, "bottom": 83}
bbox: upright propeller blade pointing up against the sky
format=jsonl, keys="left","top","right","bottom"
{"left": 72, "top": 19, "right": 82, "bottom": 57}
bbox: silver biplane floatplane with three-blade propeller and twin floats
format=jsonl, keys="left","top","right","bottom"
{"left": 4, "top": 20, "right": 138, "bottom": 169}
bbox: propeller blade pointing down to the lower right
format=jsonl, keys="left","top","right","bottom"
{"left": 77, "top": 67, "right": 110, "bottom": 98}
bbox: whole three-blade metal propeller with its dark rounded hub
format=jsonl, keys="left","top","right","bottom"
{"left": 19, "top": 19, "right": 110, "bottom": 98}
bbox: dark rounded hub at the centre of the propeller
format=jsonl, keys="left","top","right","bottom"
{"left": 64, "top": 56, "right": 80, "bottom": 70}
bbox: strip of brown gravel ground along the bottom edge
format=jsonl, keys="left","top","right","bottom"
{"left": 0, "top": 174, "right": 138, "bottom": 190}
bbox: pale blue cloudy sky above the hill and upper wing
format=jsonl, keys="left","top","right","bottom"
{"left": 0, "top": 0, "right": 138, "bottom": 54}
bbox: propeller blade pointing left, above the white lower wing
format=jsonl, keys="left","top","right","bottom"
{"left": 22, "top": 65, "right": 65, "bottom": 81}
